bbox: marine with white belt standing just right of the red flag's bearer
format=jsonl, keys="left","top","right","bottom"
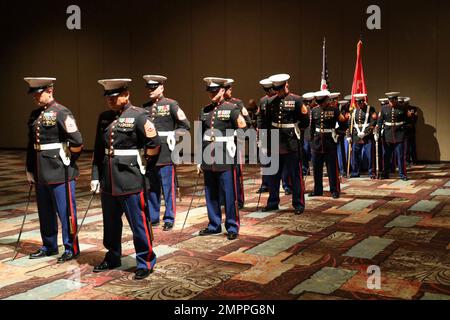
{"left": 377, "top": 92, "right": 408, "bottom": 181}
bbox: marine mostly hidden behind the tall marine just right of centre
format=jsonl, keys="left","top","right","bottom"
{"left": 256, "top": 79, "right": 276, "bottom": 193}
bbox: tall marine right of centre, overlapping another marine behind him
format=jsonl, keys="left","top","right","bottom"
{"left": 263, "top": 74, "right": 309, "bottom": 214}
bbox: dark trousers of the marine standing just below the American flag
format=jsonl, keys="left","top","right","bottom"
{"left": 312, "top": 149, "right": 341, "bottom": 194}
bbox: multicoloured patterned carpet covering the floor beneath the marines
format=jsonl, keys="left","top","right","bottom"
{"left": 0, "top": 151, "right": 450, "bottom": 300}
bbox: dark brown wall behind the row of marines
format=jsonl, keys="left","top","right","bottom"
{"left": 0, "top": 0, "right": 450, "bottom": 160}
